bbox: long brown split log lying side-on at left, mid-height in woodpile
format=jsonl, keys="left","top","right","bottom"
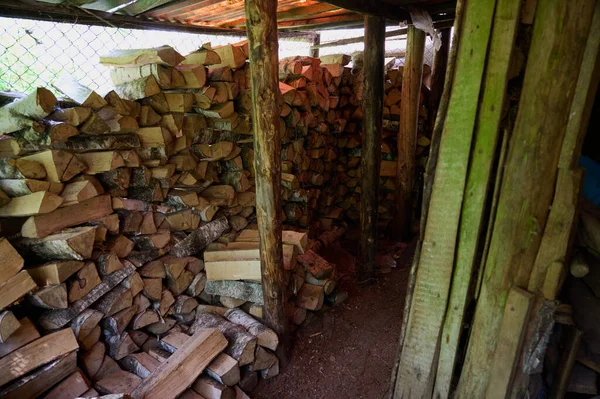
{"left": 21, "top": 194, "right": 112, "bottom": 238}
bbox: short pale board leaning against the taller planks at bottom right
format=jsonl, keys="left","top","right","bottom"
{"left": 485, "top": 287, "right": 533, "bottom": 399}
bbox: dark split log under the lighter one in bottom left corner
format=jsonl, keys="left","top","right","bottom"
{"left": 0, "top": 351, "right": 77, "bottom": 399}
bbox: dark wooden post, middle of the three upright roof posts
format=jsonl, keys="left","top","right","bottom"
{"left": 359, "top": 16, "right": 385, "bottom": 279}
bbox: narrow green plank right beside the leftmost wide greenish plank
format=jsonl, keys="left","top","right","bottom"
{"left": 435, "top": 0, "right": 521, "bottom": 398}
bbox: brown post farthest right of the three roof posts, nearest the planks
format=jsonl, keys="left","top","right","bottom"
{"left": 394, "top": 25, "right": 425, "bottom": 240}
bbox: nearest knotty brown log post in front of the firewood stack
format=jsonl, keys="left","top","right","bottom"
{"left": 246, "top": 0, "right": 290, "bottom": 364}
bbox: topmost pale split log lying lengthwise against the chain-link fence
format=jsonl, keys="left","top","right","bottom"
{"left": 100, "top": 46, "right": 185, "bottom": 68}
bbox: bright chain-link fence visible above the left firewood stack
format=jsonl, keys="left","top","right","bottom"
{"left": 0, "top": 18, "right": 310, "bottom": 94}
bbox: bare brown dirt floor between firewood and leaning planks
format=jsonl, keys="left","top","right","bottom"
{"left": 250, "top": 234, "right": 414, "bottom": 399}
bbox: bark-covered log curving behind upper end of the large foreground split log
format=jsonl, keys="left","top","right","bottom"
{"left": 190, "top": 313, "right": 256, "bottom": 366}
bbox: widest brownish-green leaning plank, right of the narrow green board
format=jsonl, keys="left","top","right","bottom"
{"left": 457, "top": 0, "right": 595, "bottom": 398}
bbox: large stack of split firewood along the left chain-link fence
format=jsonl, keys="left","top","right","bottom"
{"left": 0, "top": 43, "right": 350, "bottom": 398}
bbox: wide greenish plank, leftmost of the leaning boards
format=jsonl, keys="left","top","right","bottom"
{"left": 394, "top": 0, "right": 496, "bottom": 398}
